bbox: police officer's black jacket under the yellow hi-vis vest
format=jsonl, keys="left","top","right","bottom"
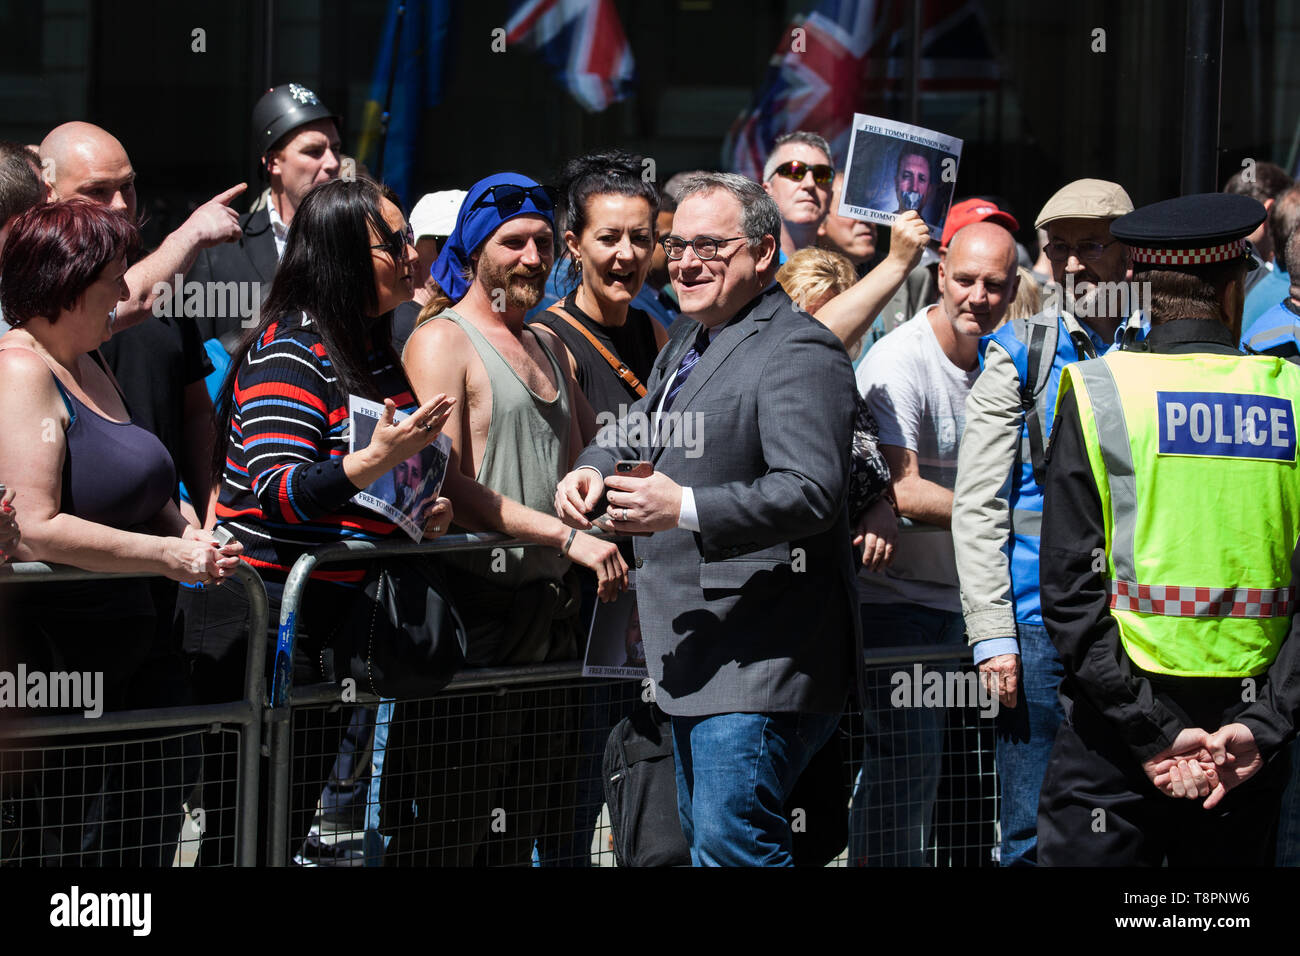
{"left": 1039, "top": 319, "right": 1300, "bottom": 761}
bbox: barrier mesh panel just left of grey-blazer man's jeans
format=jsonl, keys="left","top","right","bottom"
{"left": 279, "top": 680, "right": 641, "bottom": 866}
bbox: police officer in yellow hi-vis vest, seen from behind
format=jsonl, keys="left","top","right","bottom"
{"left": 1039, "top": 194, "right": 1300, "bottom": 866}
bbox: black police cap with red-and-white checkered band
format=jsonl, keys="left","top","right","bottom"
{"left": 1110, "top": 193, "right": 1268, "bottom": 268}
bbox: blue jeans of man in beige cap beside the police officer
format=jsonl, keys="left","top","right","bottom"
{"left": 996, "top": 622, "right": 1065, "bottom": 866}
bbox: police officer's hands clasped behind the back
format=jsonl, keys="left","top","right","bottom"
{"left": 1141, "top": 723, "right": 1264, "bottom": 810}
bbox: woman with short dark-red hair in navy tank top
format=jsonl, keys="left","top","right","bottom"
{"left": 0, "top": 200, "right": 241, "bottom": 865}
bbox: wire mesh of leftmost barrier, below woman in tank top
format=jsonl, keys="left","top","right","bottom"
{"left": 0, "top": 727, "right": 241, "bottom": 868}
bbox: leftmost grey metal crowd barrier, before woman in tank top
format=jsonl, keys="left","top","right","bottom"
{"left": 0, "top": 562, "right": 268, "bottom": 866}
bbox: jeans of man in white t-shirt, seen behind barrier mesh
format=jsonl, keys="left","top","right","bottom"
{"left": 849, "top": 604, "right": 966, "bottom": 866}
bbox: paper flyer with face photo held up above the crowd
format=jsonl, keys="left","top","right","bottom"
{"left": 837, "top": 113, "right": 962, "bottom": 239}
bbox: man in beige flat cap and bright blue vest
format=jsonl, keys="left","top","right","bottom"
{"left": 953, "top": 179, "right": 1138, "bottom": 866}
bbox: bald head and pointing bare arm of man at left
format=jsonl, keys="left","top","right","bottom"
{"left": 40, "top": 122, "right": 247, "bottom": 330}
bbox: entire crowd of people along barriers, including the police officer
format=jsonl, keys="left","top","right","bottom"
{"left": 0, "top": 85, "right": 1300, "bottom": 866}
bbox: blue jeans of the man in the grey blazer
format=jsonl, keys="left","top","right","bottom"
{"left": 672, "top": 714, "right": 840, "bottom": 866}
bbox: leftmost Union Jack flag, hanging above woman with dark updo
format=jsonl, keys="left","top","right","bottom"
{"left": 506, "top": 0, "right": 636, "bottom": 113}
